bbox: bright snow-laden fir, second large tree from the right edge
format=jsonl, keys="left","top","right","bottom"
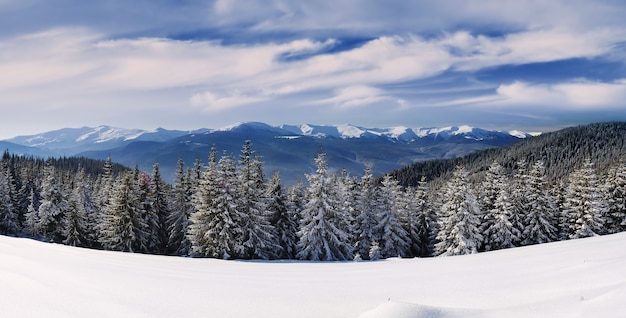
{"left": 564, "top": 159, "right": 606, "bottom": 239}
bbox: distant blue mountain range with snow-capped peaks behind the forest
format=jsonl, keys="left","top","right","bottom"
{"left": 0, "top": 122, "right": 533, "bottom": 184}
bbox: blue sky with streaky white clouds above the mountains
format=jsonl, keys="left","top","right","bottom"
{"left": 0, "top": 0, "right": 626, "bottom": 139}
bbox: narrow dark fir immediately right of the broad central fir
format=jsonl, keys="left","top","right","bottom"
{"left": 354, "top": 164, "right": 379, "bottom": 260}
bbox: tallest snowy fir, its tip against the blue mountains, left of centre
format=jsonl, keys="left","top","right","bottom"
{"left": 236, "top": 140, "right": 281, "bottom": 259}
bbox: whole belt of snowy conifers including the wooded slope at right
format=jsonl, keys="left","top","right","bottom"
{"left": 0, "top": 122, "right": 626, "bottom": 261}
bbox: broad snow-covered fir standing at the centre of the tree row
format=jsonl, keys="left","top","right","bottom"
{"left": 297, "top": 153, "right": 353, "bottom": 261}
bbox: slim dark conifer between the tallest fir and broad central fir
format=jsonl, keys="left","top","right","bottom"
{"left": 266, "top": 171, "right": 298, "bottom": 259}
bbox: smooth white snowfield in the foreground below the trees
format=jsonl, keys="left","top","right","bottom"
{"left": 0, "top": 233, "right": 626, "bottom": 318}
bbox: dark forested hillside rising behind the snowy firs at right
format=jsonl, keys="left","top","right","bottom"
{"left": 389, "top": 122, "right": 626, "bottom": 186}
